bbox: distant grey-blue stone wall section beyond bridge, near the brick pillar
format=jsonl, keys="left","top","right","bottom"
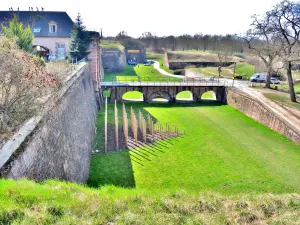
{"left": 102, "top": 49, "right": 126, "bottom": 72}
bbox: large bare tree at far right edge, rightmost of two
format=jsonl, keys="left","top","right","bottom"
{"left": 267, "top": 0, "right": 300, "bottom": 102}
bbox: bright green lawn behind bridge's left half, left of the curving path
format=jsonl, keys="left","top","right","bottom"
{"left": 104, "top": 64, "right": 181, "bottom": 82}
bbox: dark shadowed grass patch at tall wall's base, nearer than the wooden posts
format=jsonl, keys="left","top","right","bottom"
{"left": 87, "top": 151, "right": 135, "bottom": 188}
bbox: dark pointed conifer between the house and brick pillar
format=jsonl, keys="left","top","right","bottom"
{"left": 69, "top": 13, "right": 91, "bottom": 60}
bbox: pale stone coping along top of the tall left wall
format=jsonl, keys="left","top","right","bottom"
{"left": 0, "top": 62, "right": 87, "bottom": 169}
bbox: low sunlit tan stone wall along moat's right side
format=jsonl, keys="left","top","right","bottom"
{"left": 227, "top": 89, "right": 300, "bottom": 144}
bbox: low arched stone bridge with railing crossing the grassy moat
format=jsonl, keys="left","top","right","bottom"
{"left": 102, "top": 82, "right": 226, "bottom": 103}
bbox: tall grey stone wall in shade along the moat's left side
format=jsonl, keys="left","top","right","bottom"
{"left": 1, "top": 63, "right": 97, "bottom": 183}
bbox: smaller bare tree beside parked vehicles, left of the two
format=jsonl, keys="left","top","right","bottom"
{"left": 243, "top": 13, "right": 279, "bottom": 88}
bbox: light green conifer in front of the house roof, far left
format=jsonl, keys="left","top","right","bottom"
{"left": 1, "top": 14, "right": 34, "bottom": 52}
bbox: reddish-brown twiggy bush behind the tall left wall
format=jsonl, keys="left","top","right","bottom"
{"left": 0, "top": 36, "right": 60, "bottom": 140}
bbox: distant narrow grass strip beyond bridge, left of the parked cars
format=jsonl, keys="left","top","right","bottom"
{"left": 189, "top": 63, "right": 254, "bottom": 78}
